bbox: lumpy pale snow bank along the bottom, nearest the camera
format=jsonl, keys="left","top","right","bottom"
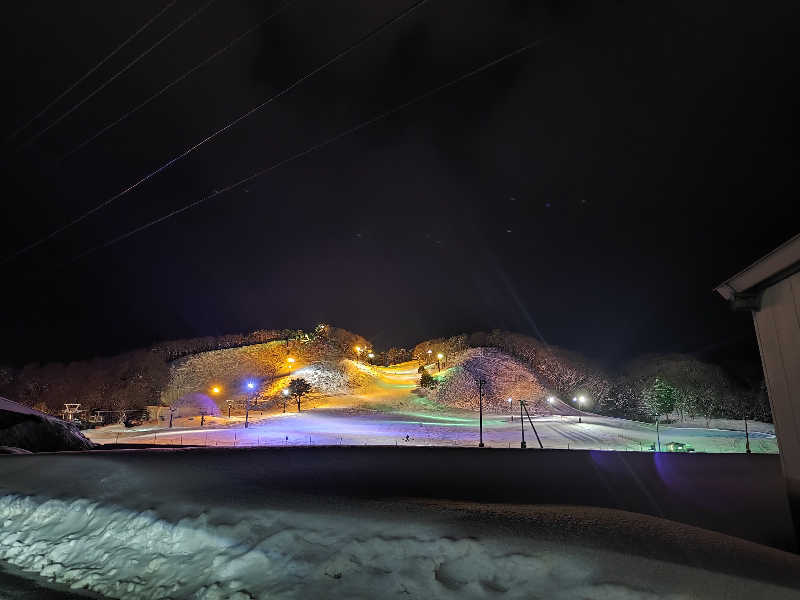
{"left": 0, "top": 495, "right": 795, "bottom": 600}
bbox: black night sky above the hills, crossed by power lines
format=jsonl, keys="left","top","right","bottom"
{"left": 0, "top": 0, "right": 800, "bottom": 364}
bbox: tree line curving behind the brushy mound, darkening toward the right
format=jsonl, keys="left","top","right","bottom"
{"left": 411, "top": 329, "right": 772, "bottom": 422}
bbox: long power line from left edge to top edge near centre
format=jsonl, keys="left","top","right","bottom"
{"left": 0, "top": 0, "right": 428, "bottom": 265}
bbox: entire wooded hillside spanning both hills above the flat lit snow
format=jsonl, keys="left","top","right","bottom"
{"left": 0, "top": 325, "right": 771, "bottom": 423}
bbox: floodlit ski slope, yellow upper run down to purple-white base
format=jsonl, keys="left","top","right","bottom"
{"left": 87, "top": 358, "right": 778, "bottom": 453}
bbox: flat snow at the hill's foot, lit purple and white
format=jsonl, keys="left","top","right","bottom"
{"left": 86, "top": 408, "right": 778, "bottom": 453}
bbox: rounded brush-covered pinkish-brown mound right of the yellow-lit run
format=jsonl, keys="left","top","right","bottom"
{"left": 430, "top": 348, "right": 547, "bottom": 412}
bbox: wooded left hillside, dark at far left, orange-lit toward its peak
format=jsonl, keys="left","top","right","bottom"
{"left": 0, "top": 325, "right": 369, "bottom": 414}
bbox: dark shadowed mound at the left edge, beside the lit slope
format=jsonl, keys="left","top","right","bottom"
{"left": 0, "top": 398, "right": 94, "bottom": 452}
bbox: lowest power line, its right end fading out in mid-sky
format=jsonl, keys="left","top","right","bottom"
{"left": 71, "top": 36, "right": 552, "bottom": 263}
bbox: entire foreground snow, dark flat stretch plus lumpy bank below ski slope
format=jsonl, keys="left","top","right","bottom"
{"left": 0, "top": 448, "right": 800, "bottom": 600}
